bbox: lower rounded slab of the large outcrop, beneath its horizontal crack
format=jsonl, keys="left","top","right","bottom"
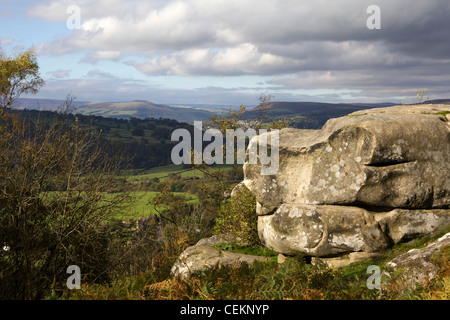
{"left": 258, "top": 204, "right": 450, "bottom": 257}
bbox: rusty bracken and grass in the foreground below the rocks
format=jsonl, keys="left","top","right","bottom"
{"left": 63, "top": 222, "right": 450, "bottom": 300}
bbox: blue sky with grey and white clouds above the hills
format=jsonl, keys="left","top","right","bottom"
{"left": 0, "top": 0, "right": 450, "bottom": 106}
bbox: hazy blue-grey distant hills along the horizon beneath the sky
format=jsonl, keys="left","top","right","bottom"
{"left": 14, "top": 99, "right": 450, "bottom": 129}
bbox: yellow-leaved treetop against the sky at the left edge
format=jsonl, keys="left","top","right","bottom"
{"left": 0, "top": 49, "right": 44, "bottom": 115}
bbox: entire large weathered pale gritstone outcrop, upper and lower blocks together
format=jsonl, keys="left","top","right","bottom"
{"left": 244, "top": 105, "right": 450, "bottom": 257}
